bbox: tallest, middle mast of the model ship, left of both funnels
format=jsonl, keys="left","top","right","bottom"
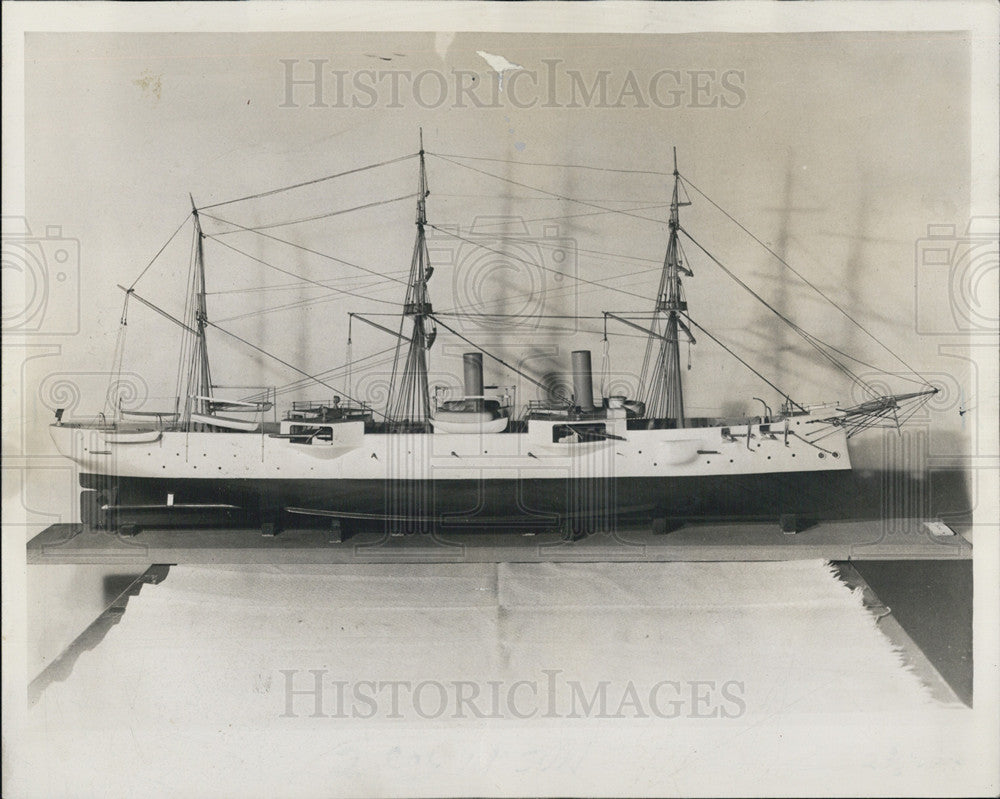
{"left": 389, "top": 128, "right": 437, "bottom": 426}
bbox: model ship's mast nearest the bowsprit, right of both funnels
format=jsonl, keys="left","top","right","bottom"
{"left": 643, "top": 147, "right": 694, "bottom": 427}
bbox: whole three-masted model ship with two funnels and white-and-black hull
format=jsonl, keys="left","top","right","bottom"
{"left": 51, "top": 136, "right": 935, "bottom": 536}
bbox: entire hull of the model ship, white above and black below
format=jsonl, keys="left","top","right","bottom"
{"left": 52, "top": 416, "right": 850, "bottom": 529}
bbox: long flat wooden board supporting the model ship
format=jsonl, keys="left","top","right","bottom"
{"left": 27, "top": 519, "right": 972, "bottom": 566}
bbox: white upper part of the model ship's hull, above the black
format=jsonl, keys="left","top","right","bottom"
{"left": 51, "top": 416, "right": 851, "bottom": 481}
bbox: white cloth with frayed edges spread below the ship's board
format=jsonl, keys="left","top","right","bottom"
{"left": 19, "top": 561, "right": 968, "bottom": 796}
